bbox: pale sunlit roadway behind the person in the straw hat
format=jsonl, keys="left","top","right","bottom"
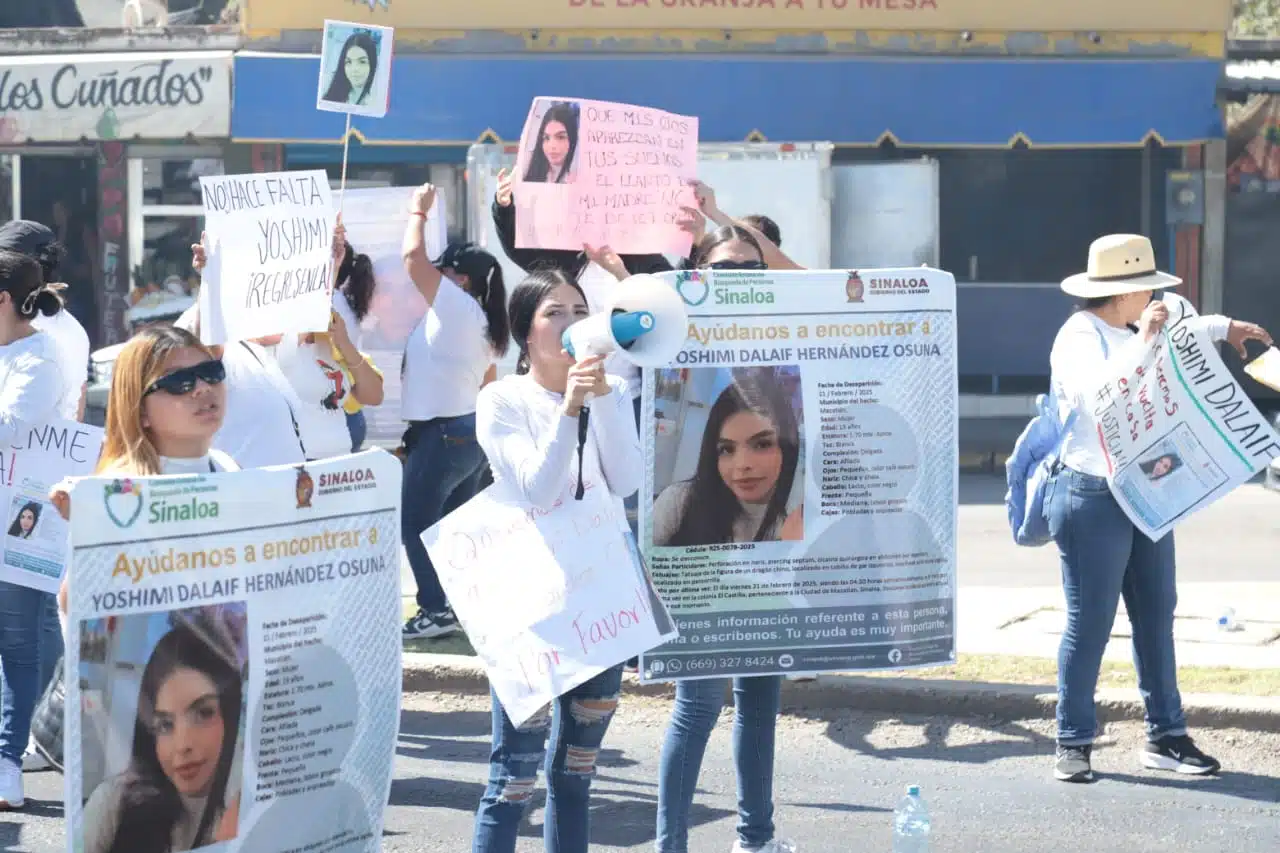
{"left": 957, "top": 475, "right": 1280, "bottom": 587}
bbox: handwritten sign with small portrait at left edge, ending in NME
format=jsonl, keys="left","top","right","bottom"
{"left": 0, "top": 420, "right": 102, "bottom": 593}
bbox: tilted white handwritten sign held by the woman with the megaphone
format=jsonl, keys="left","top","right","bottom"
{"left": 422, "top": 483, "right": 676, "bottom": 725}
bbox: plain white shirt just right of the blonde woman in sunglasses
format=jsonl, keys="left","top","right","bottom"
{"left": 214, "top": 342, "right": 306, "bottom": 467}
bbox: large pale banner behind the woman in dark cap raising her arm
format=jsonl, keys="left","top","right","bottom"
{"left": 342, "top": 187, "right": 448, "bottom": 442}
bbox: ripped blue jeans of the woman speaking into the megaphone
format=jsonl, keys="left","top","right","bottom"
{"left": 471, "top": 666, "right": 622, "bottom": 853}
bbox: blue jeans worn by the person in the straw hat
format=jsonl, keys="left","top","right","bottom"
{"left": 1044, "top": 469, "right": 1187, "bottom": 745}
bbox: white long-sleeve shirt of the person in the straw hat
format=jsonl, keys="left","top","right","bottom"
{"left": 1048, "top": 311, "right": 1231, "bottom": 476}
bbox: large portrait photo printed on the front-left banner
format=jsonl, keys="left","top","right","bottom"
{"left": 79, "top": 602, "right": 248, "bottom": 853}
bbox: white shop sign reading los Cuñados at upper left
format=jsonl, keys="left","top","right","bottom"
{"left": 0, "top": 50, "right": 232, "bottom": 143}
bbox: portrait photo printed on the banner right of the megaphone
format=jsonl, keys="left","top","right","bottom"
{"left": 652, "top": 365, "right": 804, "bottom": 547}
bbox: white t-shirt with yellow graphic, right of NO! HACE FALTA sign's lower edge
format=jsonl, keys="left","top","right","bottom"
{"left": 275, "top": 334, "right": 351, "bottom": 459}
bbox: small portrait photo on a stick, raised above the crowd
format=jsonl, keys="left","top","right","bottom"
{"left": 316, "top": 20, "right": 394, "bottom": 118}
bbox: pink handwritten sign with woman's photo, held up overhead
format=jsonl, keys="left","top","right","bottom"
{"left": 515, "top": 97, "right": 698, "bottom": 255}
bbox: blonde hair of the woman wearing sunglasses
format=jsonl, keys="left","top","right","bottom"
{"left": 97, "top": 325, "right": 215, "bottom": 476}
